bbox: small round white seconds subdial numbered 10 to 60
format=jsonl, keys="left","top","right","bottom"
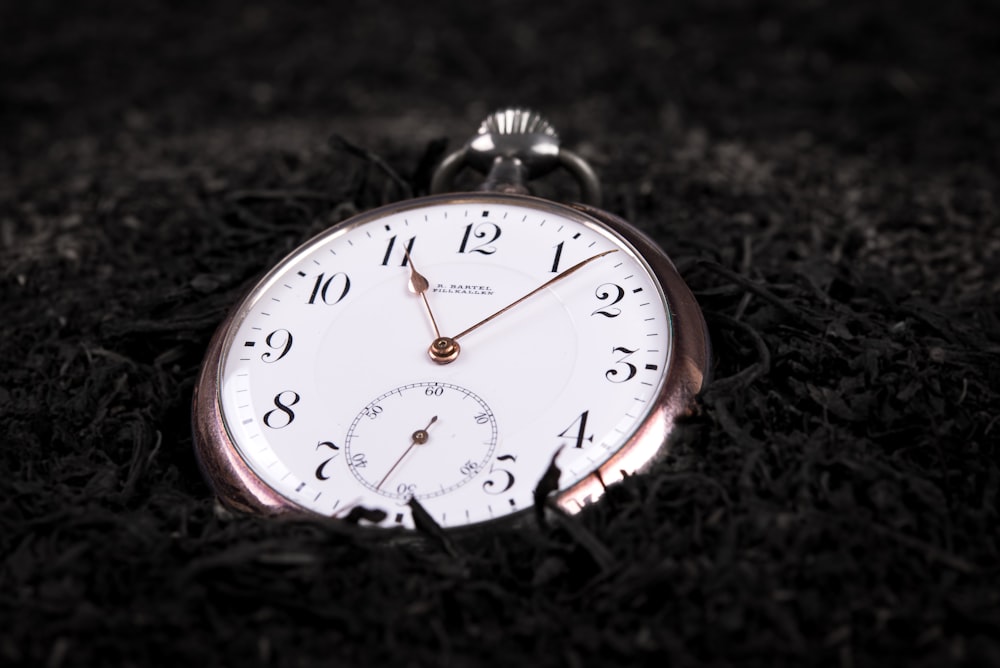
{"left": 345, "top": 382, "right": 497, "bottom": 501}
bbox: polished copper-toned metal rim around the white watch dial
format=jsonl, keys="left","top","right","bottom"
{"left": 193, "top": 193, "right": 710, "bottom": 528}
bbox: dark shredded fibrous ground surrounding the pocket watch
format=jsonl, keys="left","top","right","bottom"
{"left": 0, "top": 0, "right": 1000, "bottom": 668}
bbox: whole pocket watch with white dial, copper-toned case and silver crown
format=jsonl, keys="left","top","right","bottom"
{"left": 193, "top": 108, "right": 709, "bottom": 528}
